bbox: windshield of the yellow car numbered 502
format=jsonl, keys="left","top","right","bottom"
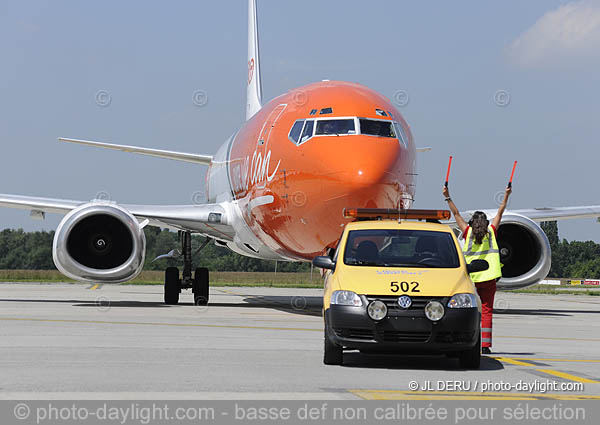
{"left": 344, "top": 229, "right": 460, "bottom": 268}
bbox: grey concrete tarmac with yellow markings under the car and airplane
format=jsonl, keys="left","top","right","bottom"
{"left": 0, "top": 283, "right": 600, "bottom": 400}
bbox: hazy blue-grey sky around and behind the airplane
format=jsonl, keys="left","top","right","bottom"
{"left": 0, "top": 0, "right": 600, "bottom": 242}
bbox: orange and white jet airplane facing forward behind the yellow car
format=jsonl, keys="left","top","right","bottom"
{"left": 0, "top": 0, "right": 600, "bottom": 304}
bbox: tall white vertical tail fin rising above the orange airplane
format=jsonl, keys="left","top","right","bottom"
{"left": 246, "top": 0, "right": 262, "bottom": 120}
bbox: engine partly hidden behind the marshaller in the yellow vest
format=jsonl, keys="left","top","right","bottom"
{"left": 498, "top": 213, "right": 552, "bottom": 289}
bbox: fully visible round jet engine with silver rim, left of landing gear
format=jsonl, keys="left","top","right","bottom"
{"left": 52, "top": 202, "right": 146, "bottom": 283}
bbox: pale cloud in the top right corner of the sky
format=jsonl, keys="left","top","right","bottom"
{"left": 507, "top": 0, "right": 600, "bottom": 68}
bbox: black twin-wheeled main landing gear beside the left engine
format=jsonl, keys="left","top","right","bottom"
{"left": 165, "top": 232, "right": 210, "bottom": 305}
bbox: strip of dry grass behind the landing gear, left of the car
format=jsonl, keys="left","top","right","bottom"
{"left": 0, "top": 270, "right": 323, "bottom": 288}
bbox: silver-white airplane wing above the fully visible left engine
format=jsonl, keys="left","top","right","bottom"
{"left": 0, "top": 194, "right": 235, "bottom": 241}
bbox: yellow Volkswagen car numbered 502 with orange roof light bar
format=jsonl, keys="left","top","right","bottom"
{"left": 313, "top": 209, "right": 488, "bottom": 369}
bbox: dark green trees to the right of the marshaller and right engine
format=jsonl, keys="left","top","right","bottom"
{"left": 542, "top": 221, "right": 600, "bottom": 279}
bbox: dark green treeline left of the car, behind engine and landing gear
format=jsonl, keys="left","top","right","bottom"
{"left": 0, "top": 227, "right": 310, "bottom": 272}
